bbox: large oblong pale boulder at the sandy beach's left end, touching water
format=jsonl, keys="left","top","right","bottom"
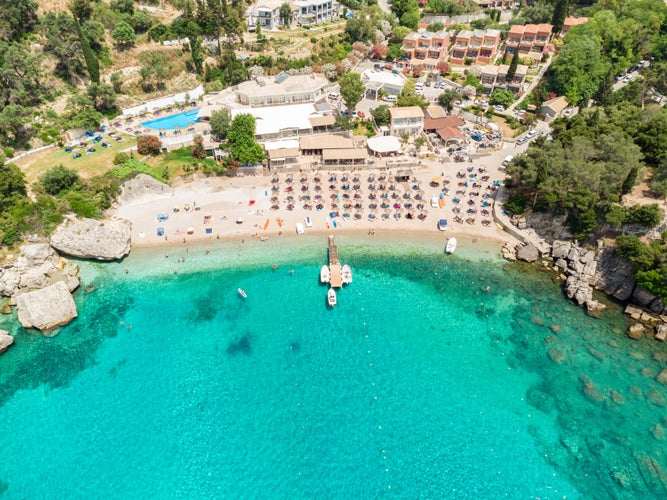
{"left": 51, "top": 217, "right": 132, "bottom": 260}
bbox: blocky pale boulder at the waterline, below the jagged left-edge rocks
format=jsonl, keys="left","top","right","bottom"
{"left": 16, "top": 281, "right": 78, "bottom": 332}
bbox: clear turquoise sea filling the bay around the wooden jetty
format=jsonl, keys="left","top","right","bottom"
{"left": 0, "top": 235, "right": 667, "bottom": 499}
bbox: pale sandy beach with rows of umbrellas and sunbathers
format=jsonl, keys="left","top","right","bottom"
{"left": 113, "top": 155, "right": 512, "bottom": 254}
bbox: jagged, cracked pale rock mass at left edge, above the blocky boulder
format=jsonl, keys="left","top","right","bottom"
{"left": 0, "top": 243, "right": 79, "bottom": 297}
